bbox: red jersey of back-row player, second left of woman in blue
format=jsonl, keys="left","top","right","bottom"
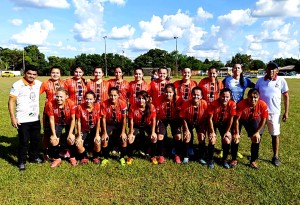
{"left": 174, "top": 80, "right": 197, "bottom": 101}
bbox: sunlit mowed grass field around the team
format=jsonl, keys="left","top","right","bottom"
{"left": 0, "top": 77, "right": 300, "bottom": 204}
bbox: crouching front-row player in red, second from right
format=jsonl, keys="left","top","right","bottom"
{"left": 207, "top": 88, "right": 236, "bottom": 169}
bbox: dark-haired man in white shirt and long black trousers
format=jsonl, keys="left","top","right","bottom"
{"left": 8, "top": 65, "right": 43, "bottom": 171}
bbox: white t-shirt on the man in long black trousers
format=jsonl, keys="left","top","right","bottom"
{"left": 10, "top": 79, "right": 42, "bottom": 123}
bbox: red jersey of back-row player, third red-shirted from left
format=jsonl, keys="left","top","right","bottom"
{"left": 86, "top": 80, "right": 109, "bottom": 103}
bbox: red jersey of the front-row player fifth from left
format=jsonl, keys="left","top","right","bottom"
{"left": 156, "top": 96, "right": 181, "bottom": 120}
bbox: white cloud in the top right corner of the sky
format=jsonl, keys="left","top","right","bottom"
{"left": 252, "top": 0, "right": 300, "bottom": 17}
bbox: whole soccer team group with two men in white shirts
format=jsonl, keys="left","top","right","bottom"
{"left": 8, "top": 62, "right": 289, "bottom": 170}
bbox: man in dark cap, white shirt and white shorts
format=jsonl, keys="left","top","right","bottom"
{"left": 255, "top": 62, "right": 289, "bottom": 166}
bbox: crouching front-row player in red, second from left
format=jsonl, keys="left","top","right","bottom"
{"left": 75, "top": 91, "right": 101, "bottom": 164}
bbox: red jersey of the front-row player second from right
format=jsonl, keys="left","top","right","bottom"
{"left": 207, "top": 99, "right": 236, "bottom": 124}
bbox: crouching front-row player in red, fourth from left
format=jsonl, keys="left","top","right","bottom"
{"left": 127, "top": 90, "right": 158, "bottom": 165}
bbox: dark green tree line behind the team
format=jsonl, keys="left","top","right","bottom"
{"left": 0, "top": 45, "right": 300, "bottom": 76}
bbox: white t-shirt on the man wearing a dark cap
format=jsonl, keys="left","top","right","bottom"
{"left": 255, "top": 76, "right": 289, "bottom": 114}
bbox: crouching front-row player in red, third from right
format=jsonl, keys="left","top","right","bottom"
{"left": 179, "top": 87, "right": 207, "bottom": 164}
